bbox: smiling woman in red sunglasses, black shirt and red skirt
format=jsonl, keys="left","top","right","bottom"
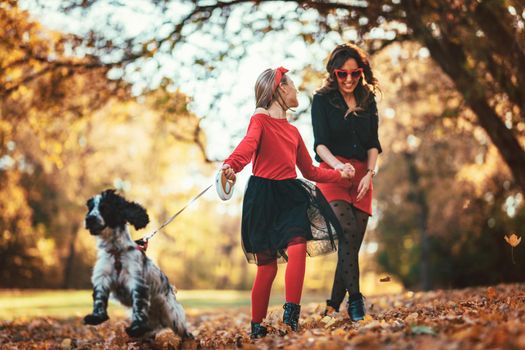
{"left": 312, "top": 44, "right": 381, "bottom": 321}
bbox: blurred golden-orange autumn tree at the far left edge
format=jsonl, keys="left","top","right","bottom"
{"left": 0, "top": 1, "right": 126, "bottom": 287}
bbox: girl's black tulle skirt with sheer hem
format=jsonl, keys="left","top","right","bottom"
{"left": 242, "top": 176, "right": 342, "bottom": 265}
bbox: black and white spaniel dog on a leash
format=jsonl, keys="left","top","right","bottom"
{"left": 84, "top": 190, "right": 191, "bottom": 338}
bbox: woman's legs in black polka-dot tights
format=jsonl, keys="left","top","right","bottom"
{"left": 330, "top": 201, "right": 368, "bottom": 309}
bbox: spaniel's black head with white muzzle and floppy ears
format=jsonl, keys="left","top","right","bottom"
{"left": 86, "top": 190, "right": 149, "bottom": 236}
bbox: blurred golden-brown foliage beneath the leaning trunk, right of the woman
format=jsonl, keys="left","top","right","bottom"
{"left": 374, "top": 43, "right": 525, "bottom": 290}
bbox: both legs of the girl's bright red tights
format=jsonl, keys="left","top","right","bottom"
{"left": 252, "top": 240, "right": 306, "bottom": 323}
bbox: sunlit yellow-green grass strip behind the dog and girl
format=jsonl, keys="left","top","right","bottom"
{"left": 0, "top": 290, "right": 324, "bottom": 320}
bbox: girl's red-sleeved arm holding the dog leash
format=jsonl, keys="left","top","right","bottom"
{"left": 224, "top": 117, "right": 262, "bottom": 173}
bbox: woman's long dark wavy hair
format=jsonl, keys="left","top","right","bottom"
{"left": 317, "top": 43, "right": 379, "bottom": 110}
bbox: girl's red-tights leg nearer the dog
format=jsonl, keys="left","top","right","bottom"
{"left": 252, "top": 260, "right": 277, "bottom": 323}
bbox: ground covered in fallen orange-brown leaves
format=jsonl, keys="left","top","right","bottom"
{"left": 0, "top": 284, "right": 525, "bottom": 350}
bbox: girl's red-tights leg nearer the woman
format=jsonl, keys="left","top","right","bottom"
{"left": 284, "top": 239, "right": 306, "bottom": 304}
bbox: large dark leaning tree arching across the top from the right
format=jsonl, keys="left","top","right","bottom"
{"left": 25, "top": 0, "right": 525, "bottom": 192}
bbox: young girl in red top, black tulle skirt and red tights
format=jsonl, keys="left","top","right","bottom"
{"left": 222, "top": 67, "right": 349, "bottom": 338}
